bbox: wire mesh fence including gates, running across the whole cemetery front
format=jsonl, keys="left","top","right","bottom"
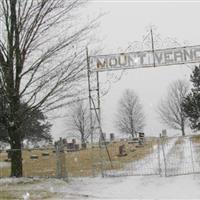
{"left": 0, "top": 136, "right": 200, "bottom": 179}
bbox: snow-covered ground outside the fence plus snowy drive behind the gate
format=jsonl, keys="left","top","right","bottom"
{"left": 0, "top": 138, "right": 200, "bottom": 200}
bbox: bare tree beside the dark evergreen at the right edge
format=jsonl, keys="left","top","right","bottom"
{"left": 158, "top": 80, "right": 189, "bottom": 136}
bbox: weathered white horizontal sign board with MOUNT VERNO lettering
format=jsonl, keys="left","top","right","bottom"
{"left": 89, "top": 45, "right": 200, "bottom": 71}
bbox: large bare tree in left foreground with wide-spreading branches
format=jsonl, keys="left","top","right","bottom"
{"left": 0, "top": 0, "right": 95, "bottom": 177}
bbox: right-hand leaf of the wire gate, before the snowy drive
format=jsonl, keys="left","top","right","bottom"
{"left": 163, "top": 136, "right": 200, "bottom": 176}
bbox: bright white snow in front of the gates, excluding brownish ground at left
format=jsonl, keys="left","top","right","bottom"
{"left": 66, "top": 175, "right": 200, "bottom": 199}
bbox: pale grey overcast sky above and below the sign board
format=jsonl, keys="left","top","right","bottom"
{"left": 53, "top": 0, "right": 200, "bottom": 141}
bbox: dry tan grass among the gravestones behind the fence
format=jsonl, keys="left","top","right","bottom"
{"left": 0, "top": 138, "right": 156, "bottom": 177}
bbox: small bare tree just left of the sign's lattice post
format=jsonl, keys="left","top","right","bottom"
{"left": 66, "top": 101, "right": 95, "bottom": 146}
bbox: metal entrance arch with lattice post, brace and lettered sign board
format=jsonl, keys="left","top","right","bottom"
{"left": 86, "top": 32, "right": 200, "bottom": 175}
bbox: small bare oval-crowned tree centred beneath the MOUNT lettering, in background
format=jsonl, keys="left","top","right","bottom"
{"left": 115, "top": 89, "right": 145, "bottom": 138}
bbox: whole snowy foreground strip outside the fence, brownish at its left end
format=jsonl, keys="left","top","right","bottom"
{"left": 0, "top": 175, "right": 200, "bottom": 200}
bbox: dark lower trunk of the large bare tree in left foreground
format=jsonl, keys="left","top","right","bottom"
{"left": 9, "top": 127, "right": 23, "bottom": 177}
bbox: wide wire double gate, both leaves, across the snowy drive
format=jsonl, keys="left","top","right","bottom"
{"left": 102, "top": 136, "right": 200, "bottom": 176}
